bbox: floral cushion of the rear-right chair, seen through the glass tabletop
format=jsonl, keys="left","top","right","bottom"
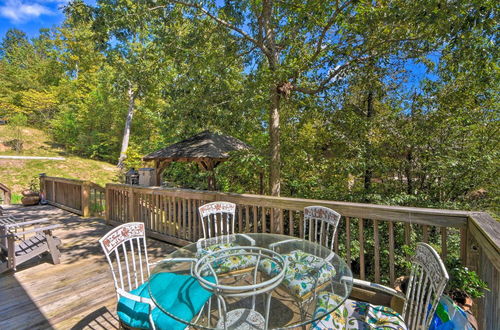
{"left": 259, "top": 250, "right": 335, "bottom": 298}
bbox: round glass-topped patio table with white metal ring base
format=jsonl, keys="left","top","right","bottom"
{"left": 149, "top": 233, "right": 352, "bottom": 329}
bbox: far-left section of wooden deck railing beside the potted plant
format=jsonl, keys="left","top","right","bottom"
{"left": 40, "top": 175, "right": 105, "bottom": 217}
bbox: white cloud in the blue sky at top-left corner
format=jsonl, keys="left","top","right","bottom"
{"left": 0, "top": 0, "right": 55, "bottom": 23}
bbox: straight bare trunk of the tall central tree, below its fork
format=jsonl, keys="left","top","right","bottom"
{"left": 269, "top": 86, "right": 281, "bottom": 196}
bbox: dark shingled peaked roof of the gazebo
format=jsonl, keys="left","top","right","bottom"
{"left": 143, "top": 131, "right": 250, "bottom": 161}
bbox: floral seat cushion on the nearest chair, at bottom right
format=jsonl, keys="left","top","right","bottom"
{"left": 312, "top": 292, "right": 407, "bottom": 330}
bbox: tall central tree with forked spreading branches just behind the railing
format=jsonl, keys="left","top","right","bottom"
{"left": 137, "top": 0, "right": 476, "bottom": 195}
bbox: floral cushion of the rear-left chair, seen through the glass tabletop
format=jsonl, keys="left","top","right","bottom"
{"left": 196, "top": 243, "right": 257, "bottom": 276}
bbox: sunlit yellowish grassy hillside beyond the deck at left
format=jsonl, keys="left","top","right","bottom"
{"left": 0, "top": 125, "right": 118, "bottom": 193}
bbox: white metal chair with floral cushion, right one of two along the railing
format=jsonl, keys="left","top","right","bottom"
{"left": 271, "top": 206, "right": 340, "bottom": 305}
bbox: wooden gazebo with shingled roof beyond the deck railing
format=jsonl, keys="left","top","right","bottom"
{"left": 143, "top": 131, "right": 251, "bottom": 190}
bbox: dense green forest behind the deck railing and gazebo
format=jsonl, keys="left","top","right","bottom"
{"left": 0, "top": 0, "right": 500, "bottom": 214}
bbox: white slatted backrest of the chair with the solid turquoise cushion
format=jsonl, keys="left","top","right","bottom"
{"left": 99, "top": 222, "right": 150, "bottom": 291}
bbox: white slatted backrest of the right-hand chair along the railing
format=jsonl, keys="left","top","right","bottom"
{"left": 303, "top": 206, "right": 340, "bottom": 250}
